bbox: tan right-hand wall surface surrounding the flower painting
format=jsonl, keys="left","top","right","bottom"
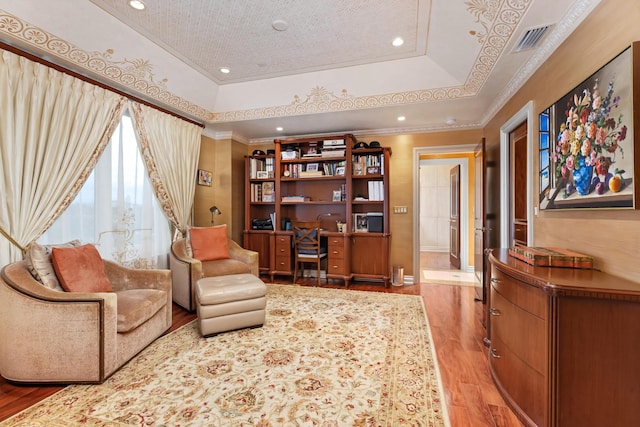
{"left": 485, "top": 0, "right": 640, "bottom": 280}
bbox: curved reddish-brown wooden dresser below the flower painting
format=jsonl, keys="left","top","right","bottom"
{"left": 487, "top": 249, "right": 640, "bottom": 427}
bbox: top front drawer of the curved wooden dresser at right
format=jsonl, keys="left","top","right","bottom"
{"left": 491, "top": 267, "right": 548, "bottom": 319}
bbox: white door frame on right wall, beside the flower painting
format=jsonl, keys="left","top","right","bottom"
{"left": 500, "top": 101, "right": 537, "bottom": 248}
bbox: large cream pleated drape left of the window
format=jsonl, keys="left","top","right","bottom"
{"left": 0, "top": 49, "right": 125, "bottom": 267}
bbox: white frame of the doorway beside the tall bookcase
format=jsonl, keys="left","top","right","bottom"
{"left": 413, "top": 145, "right": 476, "bottom": 283}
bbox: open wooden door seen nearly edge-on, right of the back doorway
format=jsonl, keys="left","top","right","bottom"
{"left": 473, "top": 138, "right": 487, "bottom": 302}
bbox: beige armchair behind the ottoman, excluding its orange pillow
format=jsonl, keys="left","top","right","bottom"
{"left": 169, "top": 239, "right": 260, "bottom": 311}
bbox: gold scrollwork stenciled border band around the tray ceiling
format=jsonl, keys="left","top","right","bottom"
{"left": 0, "top": 0, "right": 533, "bottom": 123}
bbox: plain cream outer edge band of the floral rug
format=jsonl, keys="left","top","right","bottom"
{"left": 0, "top": 283, "right": 451, "bottom": 427}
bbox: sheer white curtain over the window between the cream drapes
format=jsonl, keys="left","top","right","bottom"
{"left": 39, "top": 115, "right": 171, "bottom": 268}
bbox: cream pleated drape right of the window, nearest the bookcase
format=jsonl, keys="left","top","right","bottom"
{"left": 129, "top": 101, "right": 202, "bottom": 239}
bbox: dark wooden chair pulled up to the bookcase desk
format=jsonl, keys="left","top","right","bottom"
{"left": 291, "top": 221, "right": 327, "bottom": 286}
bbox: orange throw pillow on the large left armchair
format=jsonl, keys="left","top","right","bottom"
{"left": 51, "top": 244, "right": 113, "bottom": 292}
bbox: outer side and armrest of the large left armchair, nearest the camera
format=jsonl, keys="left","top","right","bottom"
{"left": 0, "top": 261, "right": 118, "bottom": 383}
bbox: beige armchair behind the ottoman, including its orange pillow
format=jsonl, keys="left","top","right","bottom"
{"left": 169, "top": 225, "right": 260, "bottom": 311}
